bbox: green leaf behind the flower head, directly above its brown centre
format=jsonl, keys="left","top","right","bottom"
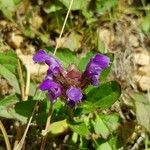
{"left": 56, "top": 48, "right": 78, "bottom": 67}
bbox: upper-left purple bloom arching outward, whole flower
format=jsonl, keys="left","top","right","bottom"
{"left": 33, "top": 50, "right": 62, "bottom": 76}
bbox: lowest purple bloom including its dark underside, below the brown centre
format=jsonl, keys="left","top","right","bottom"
{"left": 66, "top": 86, "right": 83, "bottom": 107}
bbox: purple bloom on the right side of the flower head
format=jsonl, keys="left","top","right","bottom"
{"left": 84, "top": 54, "right": 110, "bottom": 86}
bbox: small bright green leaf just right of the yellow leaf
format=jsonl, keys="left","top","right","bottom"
{"left": 69, "top": 122, "right": 90, "bottom": 136}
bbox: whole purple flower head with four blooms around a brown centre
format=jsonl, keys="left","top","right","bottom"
{"left": 33, "top": 50, "right": 110, "bottom": 107}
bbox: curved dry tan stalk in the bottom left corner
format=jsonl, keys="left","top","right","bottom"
{"left": 0, "top": 120, "right": 11, "bottom": 150}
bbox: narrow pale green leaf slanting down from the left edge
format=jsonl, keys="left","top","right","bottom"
{"left": 0, "top": 64, "right": 20, "bottom": 94}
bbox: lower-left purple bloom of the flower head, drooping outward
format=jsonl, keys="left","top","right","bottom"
{"left": 39, "top": 79, "right": 62, "bottom": 102}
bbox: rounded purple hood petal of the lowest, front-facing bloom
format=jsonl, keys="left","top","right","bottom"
{"left": 66, "top": 86, "right": 83, "bottom": 103}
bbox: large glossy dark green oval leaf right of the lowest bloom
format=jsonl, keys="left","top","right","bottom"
{"left": 82, "top": 81, "right": 121, "bottom": 113}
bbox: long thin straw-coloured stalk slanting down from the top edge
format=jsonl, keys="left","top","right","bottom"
{"left": 53, "top": 0, "right": 73, "bottom": 55}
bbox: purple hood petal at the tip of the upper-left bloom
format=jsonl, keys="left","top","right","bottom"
{"left": 33, "top": 50, "right": 49, "bottom": 63}
